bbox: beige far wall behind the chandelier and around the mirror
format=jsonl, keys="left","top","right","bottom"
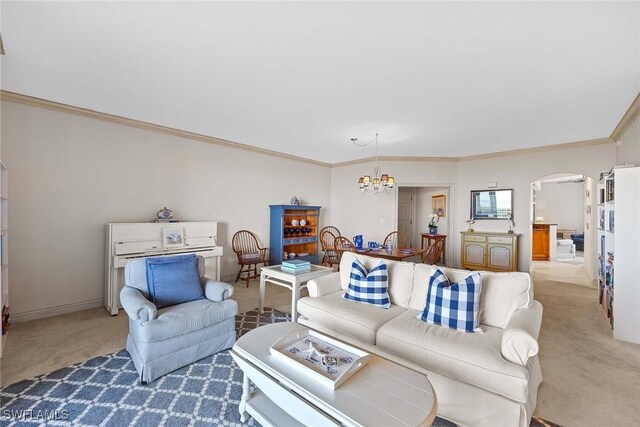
{"left": 331, "top": 144, "right": 615, "bottom": 271}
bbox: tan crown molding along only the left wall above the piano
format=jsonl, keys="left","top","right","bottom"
{"left": 0, "top": 90, "right": 331, "bottom": 167}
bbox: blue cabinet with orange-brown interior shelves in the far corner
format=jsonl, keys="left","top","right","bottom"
{"left": 269, "top": 205, "right": 320, "bottom": 265}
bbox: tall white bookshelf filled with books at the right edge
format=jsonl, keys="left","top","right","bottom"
{"left": 597, "top": 167, "right": 640, "bottom": 343}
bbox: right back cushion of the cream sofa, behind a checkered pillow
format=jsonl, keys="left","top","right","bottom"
{"left": 410, "top": 264, "right": 533, "bottom": 328}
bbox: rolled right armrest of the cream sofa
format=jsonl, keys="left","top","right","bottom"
{"left": 501, "top": 300, "right": 542, "bottom": 366}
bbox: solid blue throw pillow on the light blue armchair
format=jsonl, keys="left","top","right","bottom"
{"left": 145, "top": 254, "right": 204, "bottom": 308}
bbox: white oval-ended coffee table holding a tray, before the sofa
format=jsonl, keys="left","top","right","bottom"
{"left": 231, "top": 322, "right": 437, "bottom": 427}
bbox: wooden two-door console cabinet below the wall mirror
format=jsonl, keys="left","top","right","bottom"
{"left": 461, "top": 231, "right": 520, "bottom": 271}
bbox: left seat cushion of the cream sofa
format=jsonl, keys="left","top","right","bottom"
{"left": 298, "top": 291, "right": 405, "bottom": 344}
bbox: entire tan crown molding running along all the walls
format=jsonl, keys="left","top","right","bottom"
{"left": 0, "top": 90, "right": 616, "bottom": 168}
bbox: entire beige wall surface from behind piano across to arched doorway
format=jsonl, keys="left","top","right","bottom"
{"left": 1, "top": 102, "right": 616, "bottom": 318}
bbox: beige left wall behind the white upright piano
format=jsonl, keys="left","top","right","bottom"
{"left": 1, "top": 102, "right": 331, "bottom": 319}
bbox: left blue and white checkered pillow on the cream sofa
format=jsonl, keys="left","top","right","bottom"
{"left": 344, "top": 259, "right": 391, "bottom": 308}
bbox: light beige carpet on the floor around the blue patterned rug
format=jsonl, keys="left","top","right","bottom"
{"left": 0, "top": 272, "right": 640, "bottom": 427}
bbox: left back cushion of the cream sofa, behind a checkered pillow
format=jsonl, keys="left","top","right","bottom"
{"left": 340, "top": 252, "right": 416, "bottom": 308}
